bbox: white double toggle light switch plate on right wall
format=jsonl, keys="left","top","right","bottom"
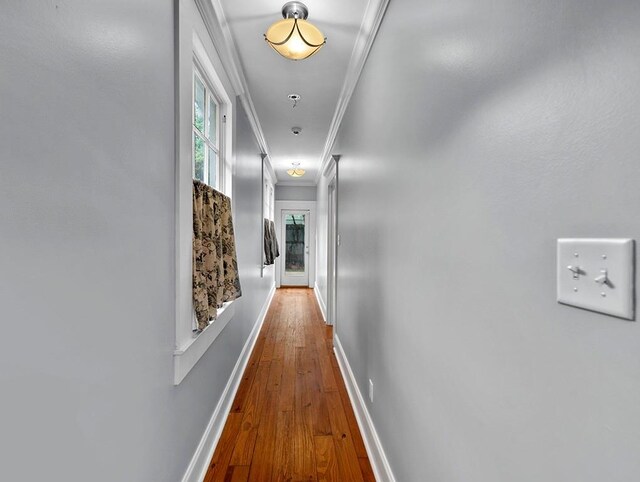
{"left": 557, "top": 238, "right": 635, "bottom": 320}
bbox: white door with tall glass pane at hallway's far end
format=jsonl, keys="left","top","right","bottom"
{"left": 280, "top": 210, "right": 310, "bottom": 286}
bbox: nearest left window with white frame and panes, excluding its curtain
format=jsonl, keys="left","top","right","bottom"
{"left": 173, "top": 22, "right": 235, "bottom": 385}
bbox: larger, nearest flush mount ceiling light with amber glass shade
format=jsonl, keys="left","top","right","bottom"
{"left": 264, "top": 2, "right": 327, "bottom": 60}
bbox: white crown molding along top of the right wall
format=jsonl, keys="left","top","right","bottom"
{"left": 315, "top": 0, "right": 390, "bottom": 183}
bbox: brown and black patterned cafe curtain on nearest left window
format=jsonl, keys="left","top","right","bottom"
{"left": 193, "top": 179, "right": 242, "bottom": 330}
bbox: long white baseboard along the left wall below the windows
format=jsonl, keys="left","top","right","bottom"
{"left": 182, "top": 286, "right": 276, "bottom": 482}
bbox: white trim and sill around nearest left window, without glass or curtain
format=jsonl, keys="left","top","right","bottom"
{"left": 173, "top": 31, "right": 237, "bottom": 385}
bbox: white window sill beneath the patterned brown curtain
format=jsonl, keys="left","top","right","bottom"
{"left": 173, "top": 300, "right": 237, "bottom": 385}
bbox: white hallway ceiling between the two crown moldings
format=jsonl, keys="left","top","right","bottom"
{"left": 221, "top": 0, "right": 371, "bottom": 184}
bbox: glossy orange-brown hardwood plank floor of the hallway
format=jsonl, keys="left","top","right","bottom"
{"left": 205, "top": 288, "right": 375, "bottom": 482}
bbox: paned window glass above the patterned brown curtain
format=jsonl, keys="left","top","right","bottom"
{"left": 192, "top": 65, "right": 221, "bottom": 188}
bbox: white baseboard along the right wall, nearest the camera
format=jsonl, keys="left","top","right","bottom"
{"left": 333, "top": 334, "right": 396, "bottom": 482}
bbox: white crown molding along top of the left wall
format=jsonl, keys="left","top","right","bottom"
{"left": 195, "top": 0, "right": 275, "bottom": 158}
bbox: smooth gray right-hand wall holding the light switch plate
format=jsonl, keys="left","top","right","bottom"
{"left": 334, "top": 0, "right": 640, "bottom": 482}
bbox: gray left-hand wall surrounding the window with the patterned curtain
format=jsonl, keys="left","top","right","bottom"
{"left": 0, "top": 0, "right": 273, "bottom": 482}
